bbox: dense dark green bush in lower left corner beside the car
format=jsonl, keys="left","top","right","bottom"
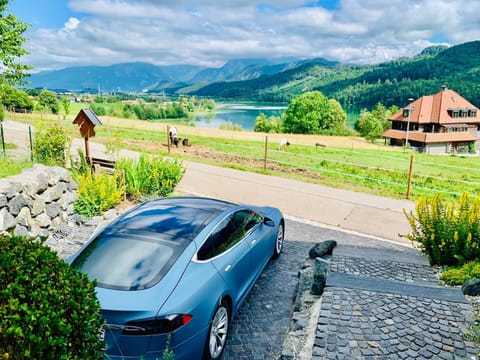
{"left": 0, "top": 236, "right": 104, "bottom": 360}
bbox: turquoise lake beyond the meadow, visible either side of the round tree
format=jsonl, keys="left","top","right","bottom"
{"left": 193, "top": 103, "right": 359, "bottom": 131}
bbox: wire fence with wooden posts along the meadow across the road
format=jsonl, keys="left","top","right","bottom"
{"left": 202, "top": 139, "right": 480, "bottom": 198}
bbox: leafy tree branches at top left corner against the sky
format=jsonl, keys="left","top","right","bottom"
{"left": 0, "top": 0, "right": 32, "bottom": 85}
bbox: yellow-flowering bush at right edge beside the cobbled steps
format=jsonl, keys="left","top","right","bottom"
{"left": 405, "top": 193, "right": 480, "bottom": 266}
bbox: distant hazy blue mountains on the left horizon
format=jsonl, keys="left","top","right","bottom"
{"left": 27, "top": 58, "right": 298, "bottom": 92}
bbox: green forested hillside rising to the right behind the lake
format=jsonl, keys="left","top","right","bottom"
{"left": 188, "top": 41, "right": 480, "bottom": 108}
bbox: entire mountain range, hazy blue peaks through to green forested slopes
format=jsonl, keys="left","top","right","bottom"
{"left": 27, "top": 41, "right": 480, "bottom": 107}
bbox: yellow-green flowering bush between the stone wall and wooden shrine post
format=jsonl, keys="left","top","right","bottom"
{"left": 74, "top": 172, "right": 125, "bottom": 217}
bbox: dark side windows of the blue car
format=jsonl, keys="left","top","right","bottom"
{"left": 197, "top": 210, "right": 261, "bottom": 260}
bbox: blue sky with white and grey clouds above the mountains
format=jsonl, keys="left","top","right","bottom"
{"left": 8, "top": 0, "right": 480, "bottom": 71}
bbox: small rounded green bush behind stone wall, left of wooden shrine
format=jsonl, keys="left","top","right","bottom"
{"left": 33, "top": 125, "right": 69, "bottom": 166}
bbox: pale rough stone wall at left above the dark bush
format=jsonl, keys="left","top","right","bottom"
{"left": 0, "top": 164, "right": 78, "bottom": 238}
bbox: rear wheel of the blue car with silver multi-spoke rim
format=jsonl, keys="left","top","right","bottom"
{"left": 203, "top": 300, "right": 230, "bottom": 360}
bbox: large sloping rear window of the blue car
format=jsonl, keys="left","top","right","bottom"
{"left": 72, "top": 231, "right": 188, "bottom": 290}
